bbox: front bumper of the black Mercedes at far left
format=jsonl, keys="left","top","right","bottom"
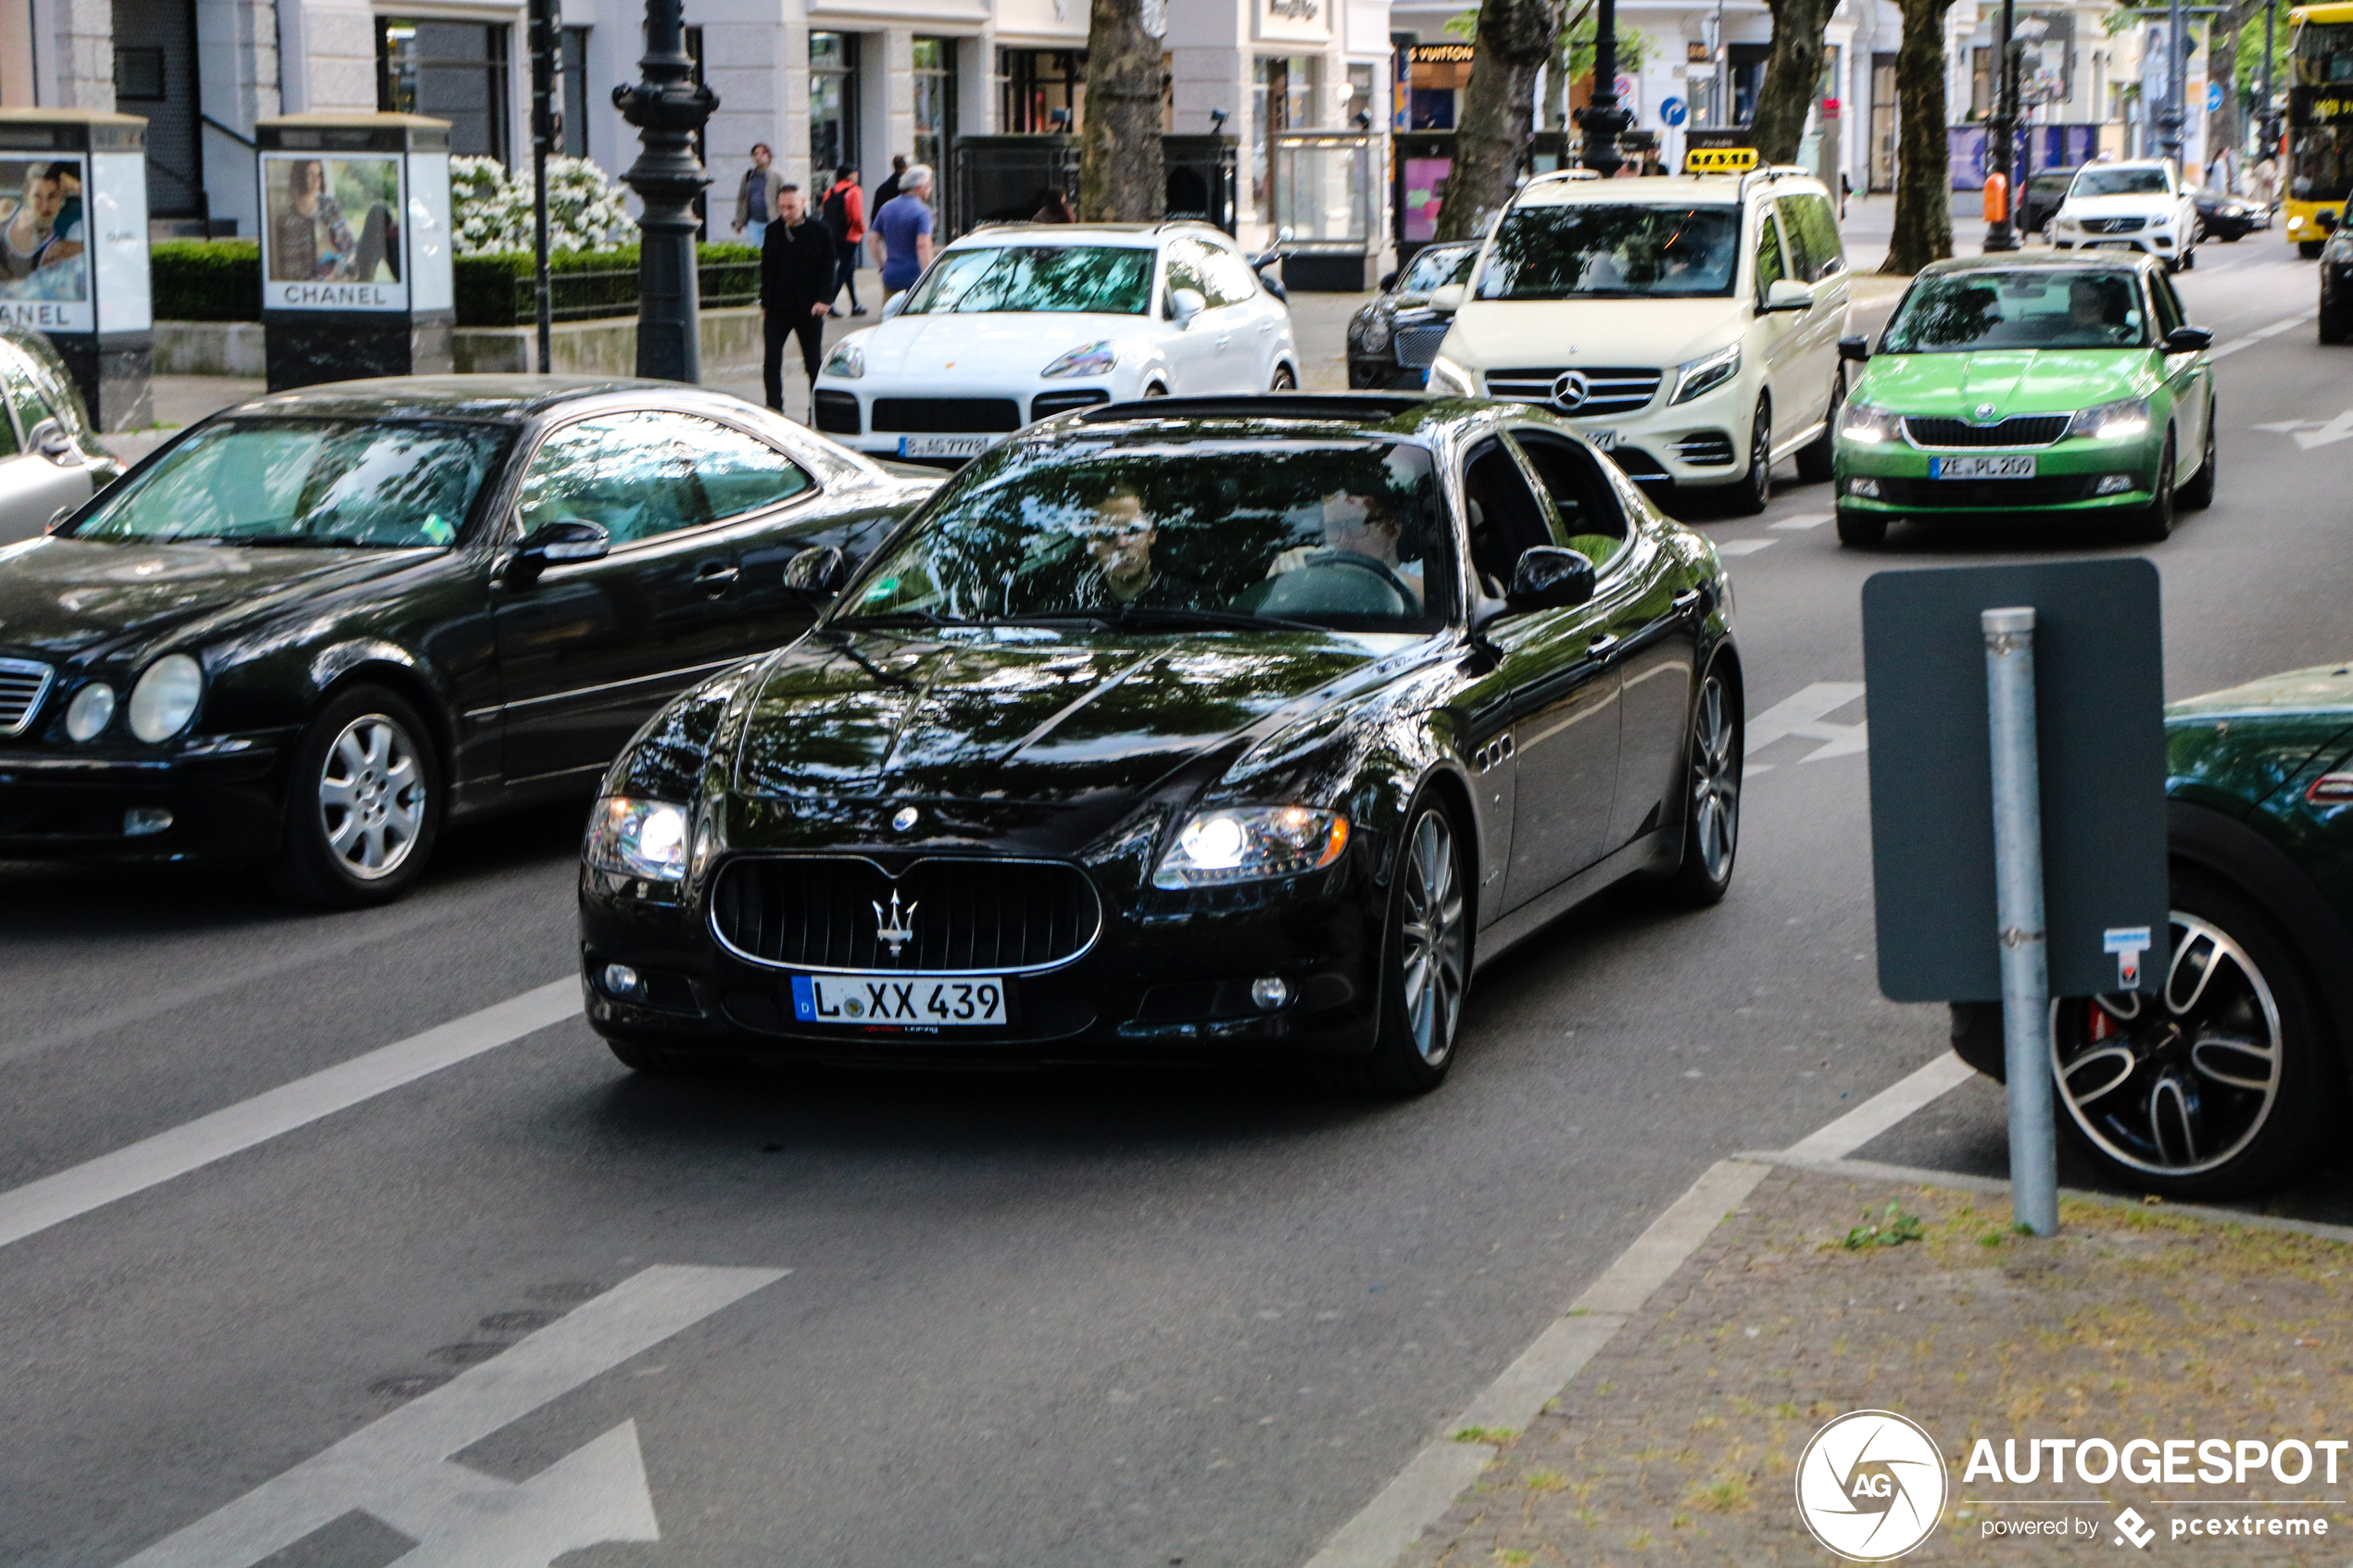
{"left": 0, "top": 731, "right": 296, "bottom": 860}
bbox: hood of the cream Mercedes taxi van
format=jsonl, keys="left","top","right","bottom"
{"left": 1438, "top": 298, "right": 1751, "bottom": 370}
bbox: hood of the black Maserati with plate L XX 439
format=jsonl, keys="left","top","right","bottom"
{"left": 734, "top": 628, "right": 1424, "bottom": 804}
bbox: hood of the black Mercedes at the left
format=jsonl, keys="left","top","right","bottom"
{"left": 0, "top": 538, "right": 440, "bottom": 663}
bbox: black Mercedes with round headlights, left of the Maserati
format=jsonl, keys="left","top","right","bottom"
{"left": 0, "top": 376, "right": 938, "bottom": 905}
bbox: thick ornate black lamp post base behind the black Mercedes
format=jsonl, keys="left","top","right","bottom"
{"left": 611, "top": 0, "right": 720, "bottom": 381}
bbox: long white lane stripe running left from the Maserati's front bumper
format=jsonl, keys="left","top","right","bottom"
{"left": 0, "top": 978, "right": 581, "bottom": 1246}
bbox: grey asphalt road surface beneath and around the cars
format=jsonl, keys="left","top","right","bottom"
{"left": 0, "top": 237, "right": 2353, "bottom": 1568}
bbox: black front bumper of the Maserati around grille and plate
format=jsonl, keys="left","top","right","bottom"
{"left": 581, "top": 847, "right": 1386, "bottom": 1065}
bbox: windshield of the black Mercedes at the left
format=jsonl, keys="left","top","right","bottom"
{"left": 70, "top": 419, "right": 506, "bottom": 550}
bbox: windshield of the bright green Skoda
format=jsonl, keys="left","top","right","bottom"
{"left": 1880, "top": 268, "right": 2148, "bottom": 355}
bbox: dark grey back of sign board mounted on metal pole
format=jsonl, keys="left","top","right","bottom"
{"left": 1864, "top": 558, "right": 2167, "bottom": 1001}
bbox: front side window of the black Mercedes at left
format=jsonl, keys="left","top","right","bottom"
{"left": 515, "top": 414, "right": 713, "bottom": 547}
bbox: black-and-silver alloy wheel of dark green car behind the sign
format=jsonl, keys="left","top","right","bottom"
{"left": 2052, "top": 909, "right": 2284, "bottom": 1178}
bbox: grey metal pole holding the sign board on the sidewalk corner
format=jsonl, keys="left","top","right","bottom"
{"left": 1982, "top": 604, "right": 2059, "bottom": 1236}
